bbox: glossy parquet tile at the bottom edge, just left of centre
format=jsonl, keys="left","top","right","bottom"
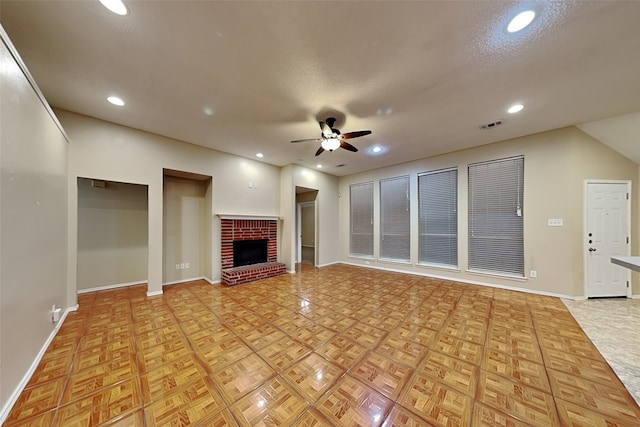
{"left": 231, "top": 377, "right": 307, "bottom": 426}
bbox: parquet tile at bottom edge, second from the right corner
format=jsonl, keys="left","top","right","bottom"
{"left": 477, "top": 371, "right": 559, "bottom": 427}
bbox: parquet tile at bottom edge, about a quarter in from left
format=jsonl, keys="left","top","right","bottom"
{"left": 144, "top": 378, "right": 225, "bottom": 427}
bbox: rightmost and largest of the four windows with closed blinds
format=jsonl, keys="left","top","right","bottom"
{"left": 469, "top": 157, "right": 524, "bottom": 277}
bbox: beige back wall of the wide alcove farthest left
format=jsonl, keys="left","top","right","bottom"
{"left": 77, "top": 178, "right": 149, "bottom": 291}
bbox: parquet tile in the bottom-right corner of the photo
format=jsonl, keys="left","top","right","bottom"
{"left": 547, "top": 369, "right": 640, "bottom": 423}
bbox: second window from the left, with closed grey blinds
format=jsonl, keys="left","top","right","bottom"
{"left": 380, "top": 176, "right": 411, "bottom": 261}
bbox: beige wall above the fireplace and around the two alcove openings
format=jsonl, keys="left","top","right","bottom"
{"left": 57, "top": 110, "right": 280, "bottom": 294}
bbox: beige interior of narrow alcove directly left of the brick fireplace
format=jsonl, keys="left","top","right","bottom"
{"left": 163, "top": 176, "right": 211, "bottom": 283}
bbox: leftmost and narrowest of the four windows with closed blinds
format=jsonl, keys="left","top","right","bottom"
{"left": 349, "top": 182, "right": 373, "bottom": 257}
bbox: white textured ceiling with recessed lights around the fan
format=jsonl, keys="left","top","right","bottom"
{"left": 0, "top": 0, "right": 640, "bottom": 176}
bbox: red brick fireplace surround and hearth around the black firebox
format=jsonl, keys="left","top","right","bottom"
{"left": 220, "top": 217, "right": 286, "bottom": 285}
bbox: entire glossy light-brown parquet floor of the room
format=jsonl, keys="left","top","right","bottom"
{"left": 5, "top": 265, "right": 640, "bottom": 427}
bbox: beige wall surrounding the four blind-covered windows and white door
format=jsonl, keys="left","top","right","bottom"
{"left": 339, "top": 127, "right": 640, "bottom": 296}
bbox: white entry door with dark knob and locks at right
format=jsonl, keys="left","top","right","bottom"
{"left": 584, "top": 182, "right": 631, "bottom": 298}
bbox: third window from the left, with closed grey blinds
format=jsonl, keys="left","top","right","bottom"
{"left": 418, "top": 169, "right": 458, "bottom": 267}
